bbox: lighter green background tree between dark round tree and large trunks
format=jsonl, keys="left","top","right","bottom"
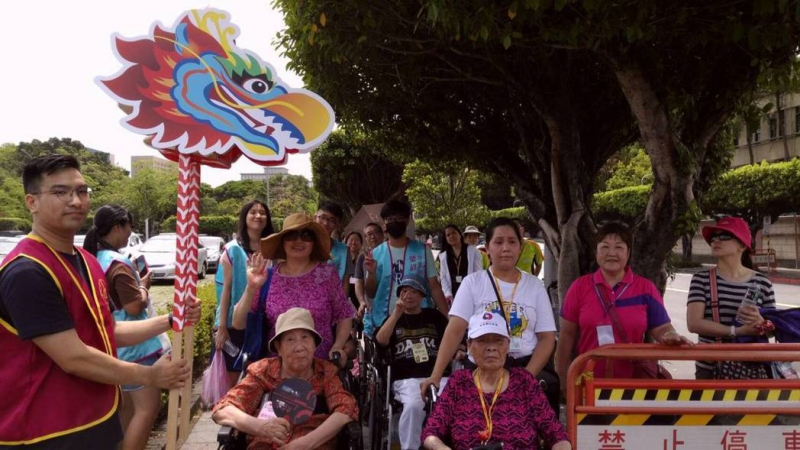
{"left": 403, "top": 161, "right": 490, "bottom": 233}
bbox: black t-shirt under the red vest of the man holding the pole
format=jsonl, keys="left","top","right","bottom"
{"left": 0, "top": 253, "right": 123, "bottom": 450}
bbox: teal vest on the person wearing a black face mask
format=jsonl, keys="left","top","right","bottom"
{"left": 364, "top": 241, "right": 433, "bottom": 335}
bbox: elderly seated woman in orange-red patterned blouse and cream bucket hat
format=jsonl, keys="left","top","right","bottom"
{"left": 213, "top": 308, "right": 358, "bottom": 450}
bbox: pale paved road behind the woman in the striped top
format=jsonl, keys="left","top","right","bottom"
{"left": 664, "top": 273, "right": 800, "bottom": 378}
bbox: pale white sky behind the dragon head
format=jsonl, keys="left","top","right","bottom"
{"left": 0, "top": 0, "right": 311, "bottom": 187}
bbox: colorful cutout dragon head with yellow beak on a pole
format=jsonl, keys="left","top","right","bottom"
{"left": 97, "top": 8, "right": 334, "bottom": 167}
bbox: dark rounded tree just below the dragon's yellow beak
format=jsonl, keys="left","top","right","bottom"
{"left": 311, "top": 130, "right": 405, "bottom": 216}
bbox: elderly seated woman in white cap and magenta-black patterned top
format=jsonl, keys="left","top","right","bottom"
{"left": 422, "top": 312, "right": 572, "bottom": 450}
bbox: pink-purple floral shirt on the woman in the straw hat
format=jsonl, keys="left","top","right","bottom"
{"left": 253, "top": 263, "right": 356, "bottom": 360}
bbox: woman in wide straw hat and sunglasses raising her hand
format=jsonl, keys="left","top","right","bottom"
{"left": 233, "top": 213, "right": 356, "bottom": 364}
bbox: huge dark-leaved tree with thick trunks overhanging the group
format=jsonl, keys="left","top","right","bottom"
{"left": 276, "top": 0, "right": 800, "bottom": 294}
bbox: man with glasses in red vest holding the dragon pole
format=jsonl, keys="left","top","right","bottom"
{"left": 0, "top": 155, "right": 199, "bottom": 449}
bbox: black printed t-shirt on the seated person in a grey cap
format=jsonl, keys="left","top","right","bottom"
{"left": 376, "top": 308, "right": 449, "bottom": 380}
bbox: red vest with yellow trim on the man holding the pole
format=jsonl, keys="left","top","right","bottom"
{"left": 0, "top": 235, "right": 119, "bottom": 446}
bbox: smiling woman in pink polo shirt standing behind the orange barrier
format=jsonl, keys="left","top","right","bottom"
{"left": 556, "top": 222, "right": 691, "bottom": 388}
